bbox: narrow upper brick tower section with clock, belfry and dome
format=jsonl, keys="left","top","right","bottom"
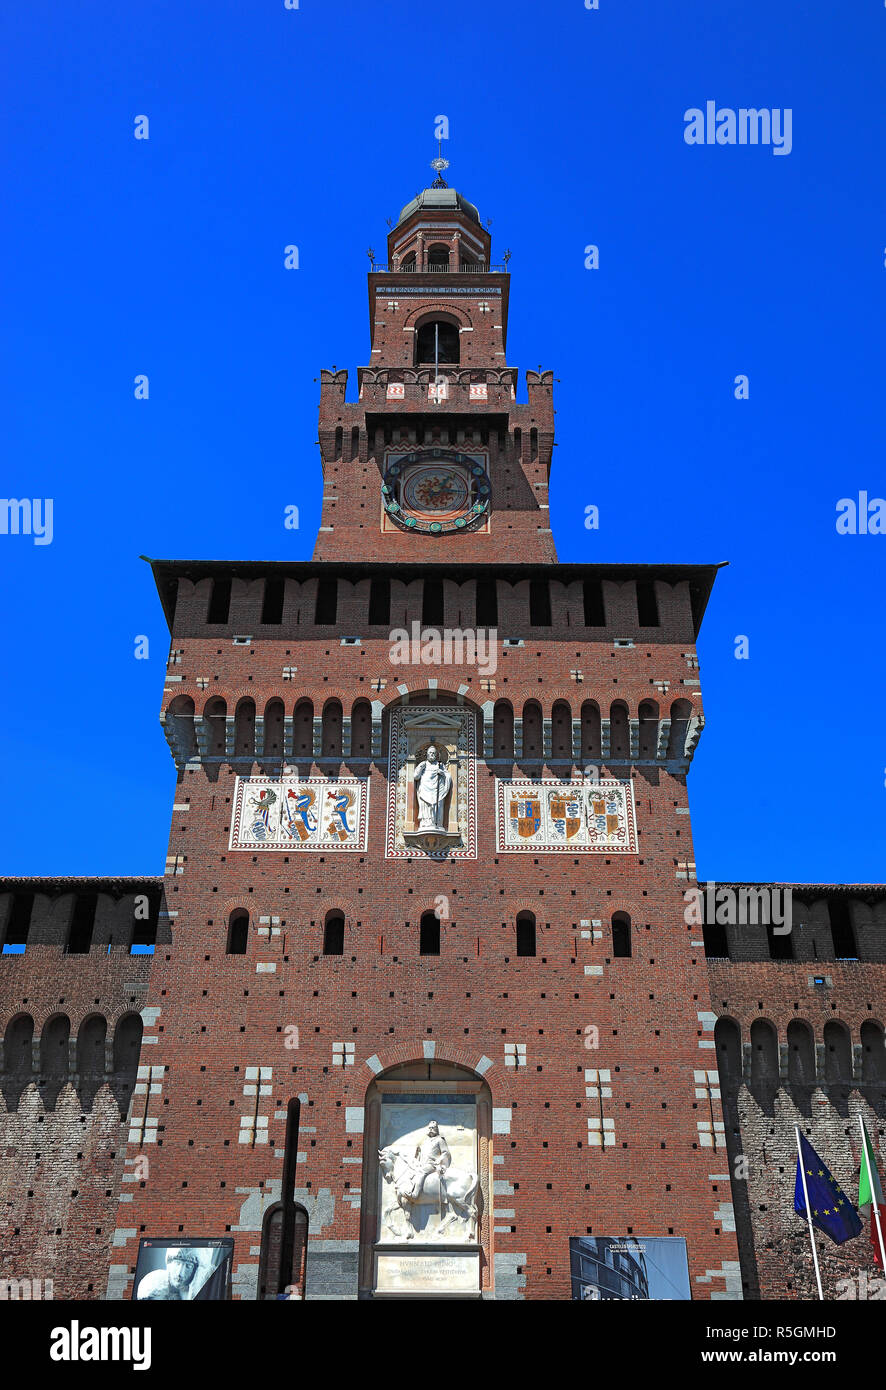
{"left": 314, "top": 160, "right": 556, "bottom": 564}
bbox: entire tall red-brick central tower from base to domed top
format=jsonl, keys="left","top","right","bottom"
{"left": 108, "top": 170, "right": 741, "bottom": 1298}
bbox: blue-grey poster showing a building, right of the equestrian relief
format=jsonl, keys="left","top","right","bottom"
{"left": 569, "top": 1236, "right": 693, "bottom": 1302}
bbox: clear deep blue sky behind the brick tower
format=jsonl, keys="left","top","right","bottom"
{"left": 0, "top": 0, "right": 886, "bottom": 881}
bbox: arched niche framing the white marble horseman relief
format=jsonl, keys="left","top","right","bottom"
{"left": 360, "top": 1059, "right": 492, "bottom": 1298}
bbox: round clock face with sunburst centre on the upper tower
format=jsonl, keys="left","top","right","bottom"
{"left": 381, "top": 449, "right": 490, "bottom": 535}
